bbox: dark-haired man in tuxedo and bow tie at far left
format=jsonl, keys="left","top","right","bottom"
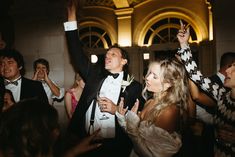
{"left": 0, "top": 49, "right": 48, "bottom": 102}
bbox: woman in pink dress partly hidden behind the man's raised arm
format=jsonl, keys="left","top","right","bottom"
{"left": 65, "top": 73, "right": 85, "bottom": 119}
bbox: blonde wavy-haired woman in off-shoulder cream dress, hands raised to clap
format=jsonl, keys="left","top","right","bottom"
{"left": 116, "top": 58, "right": 190, "bottom": 157}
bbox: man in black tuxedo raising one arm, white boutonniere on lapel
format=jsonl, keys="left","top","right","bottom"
{"left": 64, "top": 1, "right": 142, "bottom": 157}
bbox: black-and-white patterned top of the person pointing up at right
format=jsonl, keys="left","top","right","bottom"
{"left": 178, "top": 46, "right": 235, "bottom": 157}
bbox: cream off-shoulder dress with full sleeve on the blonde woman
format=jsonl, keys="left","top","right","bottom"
{"left": 116, "top": 111, "right": 182, "bottom": 157}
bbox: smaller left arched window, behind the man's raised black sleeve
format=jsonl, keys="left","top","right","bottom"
{"left": 79, "top": 26, "right": 112, "bottom": 48}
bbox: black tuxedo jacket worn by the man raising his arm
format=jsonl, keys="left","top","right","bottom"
{"left": 66, "top": 30, "right": 142, "bottom": 157}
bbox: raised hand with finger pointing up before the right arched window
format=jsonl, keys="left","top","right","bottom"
{"left": 177, "top": 20, "right": 190, "bottom": 48}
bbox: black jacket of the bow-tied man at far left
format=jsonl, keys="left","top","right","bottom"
{"left": 20, "top": 77, "right": 48, "bottom": 103}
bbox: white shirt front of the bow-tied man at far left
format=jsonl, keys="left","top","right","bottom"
{"left": 5, "top": 76, "right": 22, "bottom": 102}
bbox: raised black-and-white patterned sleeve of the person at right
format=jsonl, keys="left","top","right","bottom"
{"left": 177, "top": 46, "right": 225, "bottom": 100}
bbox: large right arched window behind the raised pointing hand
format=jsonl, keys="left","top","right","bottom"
{"left": 144, "top": 18, "right": 197, "bottom": 45}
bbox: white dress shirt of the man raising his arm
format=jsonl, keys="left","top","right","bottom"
{"left": 86, "top": 72, "right": 123, "bottom": 138}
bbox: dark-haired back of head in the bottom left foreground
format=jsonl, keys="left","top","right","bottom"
{"left": 0, "top": 98, "right": 58, "bottom": 157}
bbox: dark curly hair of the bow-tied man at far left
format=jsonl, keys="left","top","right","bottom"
{"left": 0, "top": 49, "right": 25, "bottom": 75}
